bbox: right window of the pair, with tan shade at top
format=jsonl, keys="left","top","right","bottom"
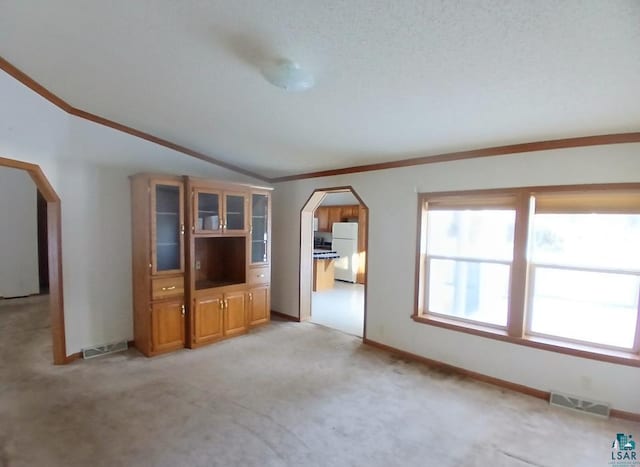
{"left": 527, "top": 194, "right": 640, "bottom": 350}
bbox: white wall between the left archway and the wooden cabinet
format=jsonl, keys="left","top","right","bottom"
{"left": 0, "top": 72, "right": 264, "bottom": 355}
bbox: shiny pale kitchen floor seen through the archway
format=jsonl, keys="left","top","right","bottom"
{"left": 311, "top": 281, "right": 364, "bottom": 337}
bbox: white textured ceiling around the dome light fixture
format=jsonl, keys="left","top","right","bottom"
{"left": 0, "top": 0, "right": 640, "bottom": 176}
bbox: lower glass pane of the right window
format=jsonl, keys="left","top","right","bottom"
{"left": 531, "top": 267, "right": 640, "bottom": 348}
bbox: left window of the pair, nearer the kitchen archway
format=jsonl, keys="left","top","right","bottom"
{"left": 425, "top": 198, "right": 515, "bottom": 328}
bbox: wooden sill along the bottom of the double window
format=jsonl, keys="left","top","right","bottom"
{"left": 411, "top": 315, "right": 640, "bottom": 367}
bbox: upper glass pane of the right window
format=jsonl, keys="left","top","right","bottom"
{"left": 532, "top": 214, "right": 640, "bottom": 271}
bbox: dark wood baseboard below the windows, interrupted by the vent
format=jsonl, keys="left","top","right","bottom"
{"left": 363, "top": 339, "right": 640, "bottom": 421}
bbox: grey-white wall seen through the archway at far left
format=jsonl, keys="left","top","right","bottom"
{"left": 0, "top": 167, "right": 40, "bottom": 298}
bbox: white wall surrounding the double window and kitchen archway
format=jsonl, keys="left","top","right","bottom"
{"left": 271, "top": 144, "right": 640, "bottom": 413}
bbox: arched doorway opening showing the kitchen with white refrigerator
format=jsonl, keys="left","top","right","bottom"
{"left": 300, "top": 186, "right": 369, "bottom": 339}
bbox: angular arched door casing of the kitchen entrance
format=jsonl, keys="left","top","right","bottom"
{"left": 299, "top": 186, "right": 369, "bottom": 339}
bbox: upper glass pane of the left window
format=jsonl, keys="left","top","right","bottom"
{"left": 427, "top": 209, "right": 516, "bottom": 261}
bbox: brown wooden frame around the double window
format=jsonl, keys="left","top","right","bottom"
{"left": 411, "top": 183, "right": 640, "bottom": 367}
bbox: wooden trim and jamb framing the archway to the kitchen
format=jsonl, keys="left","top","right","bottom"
{"left": 297, "top": 185, "right": 370, "bottom": 342}
